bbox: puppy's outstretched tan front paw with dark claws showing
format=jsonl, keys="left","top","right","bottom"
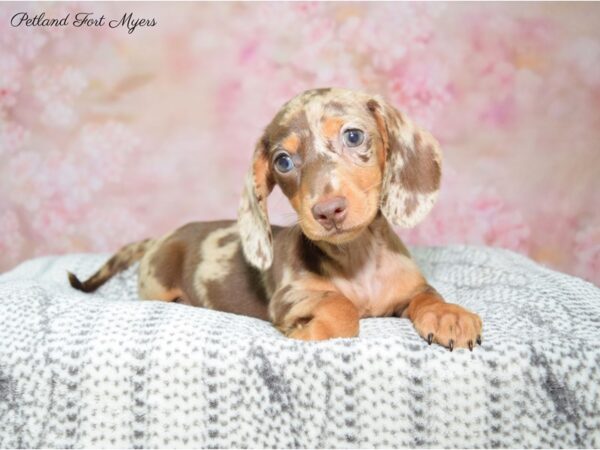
{"left": 413, "top": 302, "right": 482, "bottom": 351}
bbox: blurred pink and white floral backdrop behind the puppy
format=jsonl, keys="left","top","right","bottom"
{"left": 0, "top": 3, "right": 600, "bottom": 284}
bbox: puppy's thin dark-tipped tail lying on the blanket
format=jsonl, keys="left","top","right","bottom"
{"left": 67, "top": 239, "right": 154, "bottom": 292}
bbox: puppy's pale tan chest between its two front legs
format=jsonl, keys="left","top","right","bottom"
{"left": 331, "top": 249, "right": 424, "bottom": 317}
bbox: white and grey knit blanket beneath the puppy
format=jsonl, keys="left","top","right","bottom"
{"left": 0, "top": 246, "right": 600, "bottom": 448}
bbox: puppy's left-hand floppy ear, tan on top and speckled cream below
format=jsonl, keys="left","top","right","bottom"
{"left": 238, "top": 137, "right": 275, "bottom": 270}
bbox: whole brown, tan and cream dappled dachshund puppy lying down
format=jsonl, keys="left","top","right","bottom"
{"left": 69, "top": 89, "right": 482, "bottom": 350}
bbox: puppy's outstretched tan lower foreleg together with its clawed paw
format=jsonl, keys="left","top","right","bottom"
{"left": 398, "top": 285, "right": 482, "bottom": 351}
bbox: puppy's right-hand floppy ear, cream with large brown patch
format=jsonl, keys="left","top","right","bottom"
{"left": 367, "top": 97, "right": 442, "bottom": 228}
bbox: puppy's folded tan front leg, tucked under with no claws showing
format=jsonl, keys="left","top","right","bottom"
{"left": 276, "top": 291, "right": 359, "bottom": 341}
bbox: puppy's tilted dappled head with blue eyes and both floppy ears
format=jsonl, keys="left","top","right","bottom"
{"left": 238, "top": 89, "right": 441, "bottom": 270}
